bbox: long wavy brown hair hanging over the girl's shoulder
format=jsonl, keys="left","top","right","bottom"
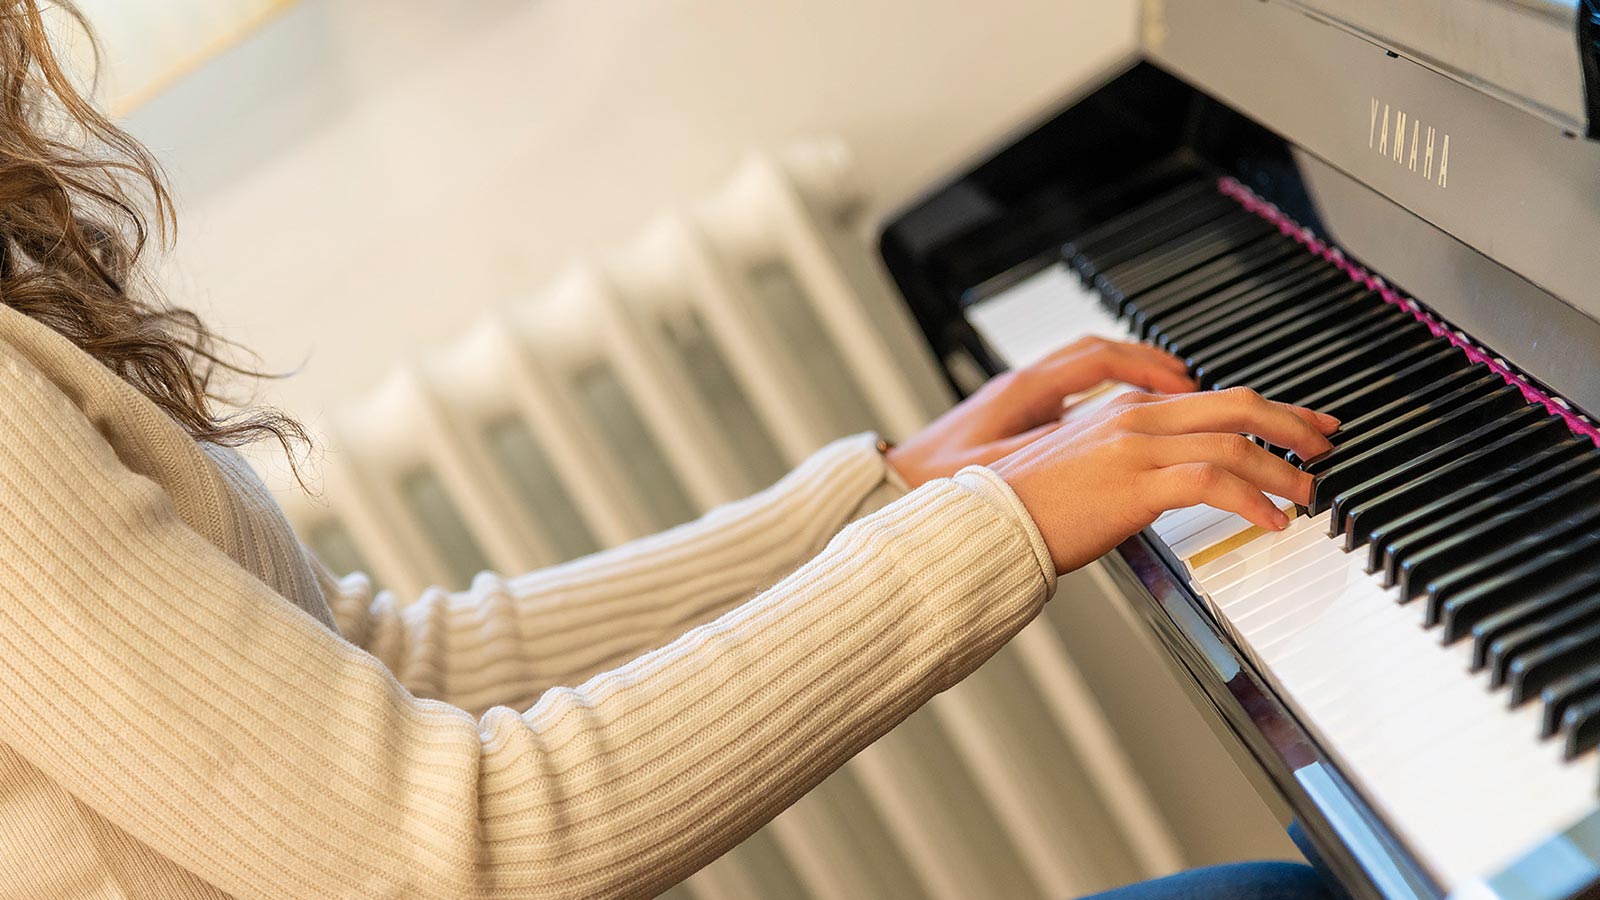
{"left": 0, "top": 0, "right": 307, "bottom": 464}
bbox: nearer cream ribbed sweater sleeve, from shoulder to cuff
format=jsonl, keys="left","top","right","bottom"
{"left": 0, "top": 342, "right": 1051, "bottom": 900}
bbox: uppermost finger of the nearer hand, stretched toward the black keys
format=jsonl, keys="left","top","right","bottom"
{"left": 1126, "top": 388, "right": 1338, "bottom": 460}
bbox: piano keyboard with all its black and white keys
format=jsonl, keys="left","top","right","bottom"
{"left": 966, "top": 181, "right": 1600, "bottom": 890}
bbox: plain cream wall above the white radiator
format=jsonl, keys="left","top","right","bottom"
{"left": 130, "top": 0, "right": 1134, "bottom": 426}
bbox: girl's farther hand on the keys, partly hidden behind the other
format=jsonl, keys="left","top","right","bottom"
{"left": 888, "top": 338, "right": 1195, "bottom": 487}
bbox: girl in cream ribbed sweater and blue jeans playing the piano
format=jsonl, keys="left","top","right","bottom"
{"left": 0, "top": 0, "right": 1336, "bottom": 900}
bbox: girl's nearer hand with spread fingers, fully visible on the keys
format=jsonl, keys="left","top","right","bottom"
{"left": 989, "top": 381, "right": 1339, "bottom": 573}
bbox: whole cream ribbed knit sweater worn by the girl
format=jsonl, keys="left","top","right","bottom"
{"left": 0, "top": 307, "right": 1053, "bottom": 900}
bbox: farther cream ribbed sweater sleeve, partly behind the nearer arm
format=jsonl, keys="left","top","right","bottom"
{"left": 322, "top": 434, "right": 904, "bottom": 711}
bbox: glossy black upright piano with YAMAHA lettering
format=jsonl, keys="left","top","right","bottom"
{"left": 880, "top": 0, "right": 1600, "bottom": 900}
